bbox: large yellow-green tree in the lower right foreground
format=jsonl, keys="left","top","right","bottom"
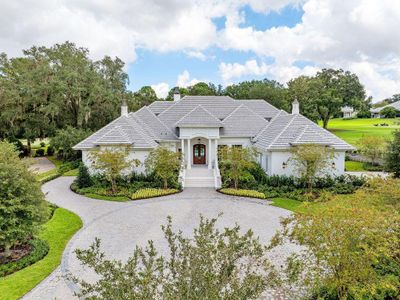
{"left": 272, "top": 179, "right": 400, "bottom": 299}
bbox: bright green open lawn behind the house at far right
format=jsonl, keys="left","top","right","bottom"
{"left": 328, "top": 119, "right": 400, "bottom": 146}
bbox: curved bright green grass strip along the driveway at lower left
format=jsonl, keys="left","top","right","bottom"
{"left": 0, "top": 208, "right": 82, "bottom": 300}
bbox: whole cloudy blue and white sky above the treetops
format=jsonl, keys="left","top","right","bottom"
{"left": 0, "top": 0, "right": 400, "bottom": 102}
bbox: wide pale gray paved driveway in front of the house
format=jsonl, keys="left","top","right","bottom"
{"left": 24, "top": 177, "right": 295, "bottom": 299}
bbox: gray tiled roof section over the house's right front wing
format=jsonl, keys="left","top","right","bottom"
{"left": 254, "top": 114, "right": 355, "bottom": 150}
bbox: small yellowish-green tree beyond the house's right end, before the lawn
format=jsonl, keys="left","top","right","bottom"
{"left": 358, "top": 135, "right": 386, "bottom": 165}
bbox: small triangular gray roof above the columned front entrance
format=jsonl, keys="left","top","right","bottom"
{"left": 175, "top": 105, "right": 222, "bottom": 127}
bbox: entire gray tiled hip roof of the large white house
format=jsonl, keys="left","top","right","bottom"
{"left": 74, "top": 96, "right": 354, "bottom": 150}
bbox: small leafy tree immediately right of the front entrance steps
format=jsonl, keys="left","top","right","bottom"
{"left": 219, "top": 147, "right": 256, "bottom": 189}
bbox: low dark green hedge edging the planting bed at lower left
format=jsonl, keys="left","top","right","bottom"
{"left": 0, "top": 239, "right": 50, "bottom": 277}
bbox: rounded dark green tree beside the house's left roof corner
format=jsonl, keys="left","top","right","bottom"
{"left": 50, "top": 126, "right": 90, "bottom": 160}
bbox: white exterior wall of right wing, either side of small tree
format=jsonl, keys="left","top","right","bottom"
{"left": 267, "top": 151, "right": 345, "bottom": 176}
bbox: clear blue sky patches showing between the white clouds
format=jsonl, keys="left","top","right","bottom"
{"left": 128, "top": 5, "right": 304, "bottom": 95}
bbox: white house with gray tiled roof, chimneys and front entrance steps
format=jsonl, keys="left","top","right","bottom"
{"left": 74, "top": 91, "right": 354, "bottom": 188}
